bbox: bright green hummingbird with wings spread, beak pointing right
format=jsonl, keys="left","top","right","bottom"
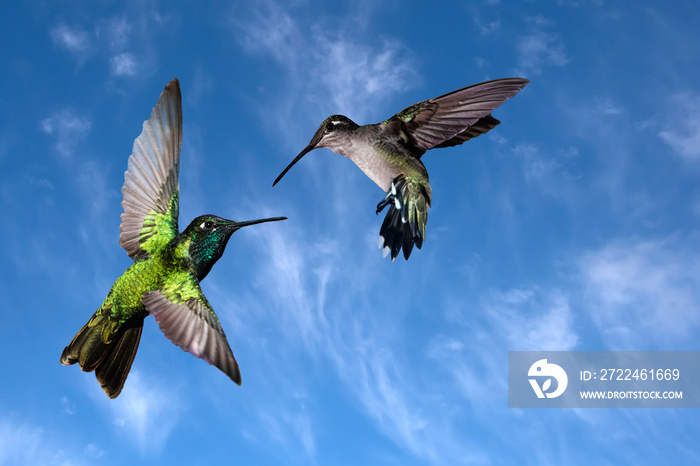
{"left": 61, "top": 79, "right": 286, "bottom": 398}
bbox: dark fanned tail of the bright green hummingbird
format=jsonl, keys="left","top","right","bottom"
{"left": 61, "top": 311, "right": 143, "bottom": 398}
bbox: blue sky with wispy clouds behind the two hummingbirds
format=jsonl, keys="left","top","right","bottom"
{"left": 0, "top": 0, "right": 700, "bottom": 465}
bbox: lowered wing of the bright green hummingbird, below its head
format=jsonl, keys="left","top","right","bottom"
{"left": 141, "top": 272, "right": 241, "bottom": 385}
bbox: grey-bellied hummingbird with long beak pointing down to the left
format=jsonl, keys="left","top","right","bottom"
{"left": 272, "top": 78, "right": 530, "bottom": 262}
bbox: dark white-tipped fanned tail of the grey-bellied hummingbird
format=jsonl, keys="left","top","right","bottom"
{"left": 377, "top": 175, "right": 431, "bottom": 262}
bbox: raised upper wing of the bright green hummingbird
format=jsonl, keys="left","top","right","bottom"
{"left": 119, "top": 79, "right": 182, "bottom": 261}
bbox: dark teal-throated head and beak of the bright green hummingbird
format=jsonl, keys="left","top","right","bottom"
{"left": 182, "top": 215, "right": 287, "bottom": 281}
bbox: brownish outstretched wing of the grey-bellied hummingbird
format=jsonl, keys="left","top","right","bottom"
{"left": 386, "top": 78, "right": 530, "bottom": 156}
